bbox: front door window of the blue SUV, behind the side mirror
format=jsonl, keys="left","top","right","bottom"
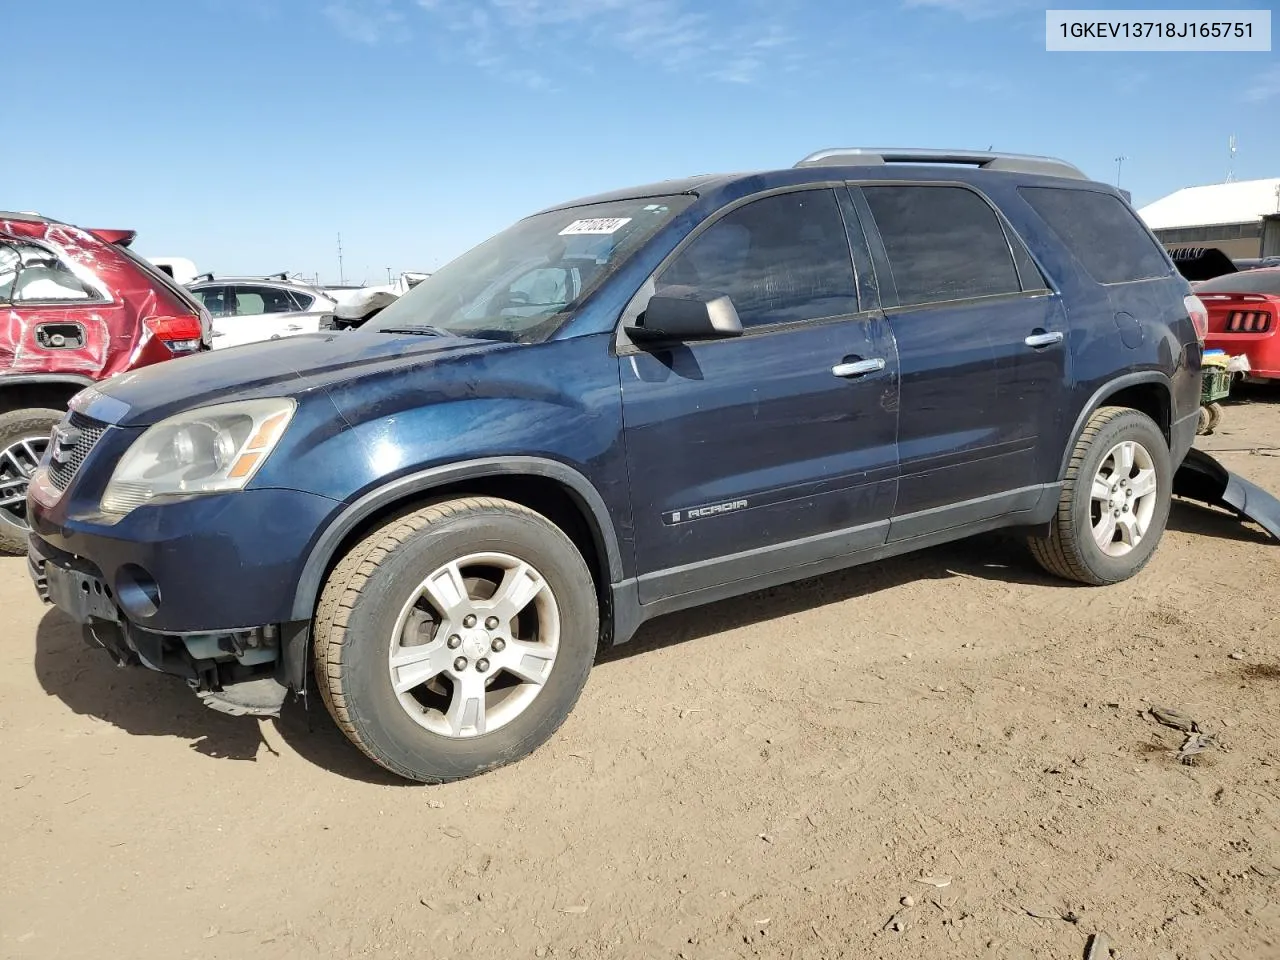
{"left": 658, "top": 189, "right": 858, "bottom": 326}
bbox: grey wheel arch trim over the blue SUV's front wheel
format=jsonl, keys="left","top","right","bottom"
{"left": 292, "top": 457, "right": 622, "bottom": 621}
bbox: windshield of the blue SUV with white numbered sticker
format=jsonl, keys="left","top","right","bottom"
{"left": 364, "top": 196, "right": 694, "bottom": 343}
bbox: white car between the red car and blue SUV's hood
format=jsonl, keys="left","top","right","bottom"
{"left": 187, "top": 274, "right": 338, "bottom": 349}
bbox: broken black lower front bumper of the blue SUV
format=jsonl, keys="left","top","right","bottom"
{"left": 27, "top": 536, "right": 308, "bottom": 717}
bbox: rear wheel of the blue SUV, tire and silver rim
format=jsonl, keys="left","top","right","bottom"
{"left": 1029, "top": 407, "right": 1172, "bottom": 585}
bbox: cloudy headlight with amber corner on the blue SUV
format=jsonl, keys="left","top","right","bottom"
{"left": 102, "top": 398, "right": 297, "bottom": 516}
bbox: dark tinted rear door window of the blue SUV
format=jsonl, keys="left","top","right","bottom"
{"left": 861, "top": 186, "right": 1021, "bottom": 306}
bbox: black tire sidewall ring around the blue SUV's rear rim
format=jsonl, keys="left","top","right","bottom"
{"left": 1071, "top": 411, "right": 1174, "bottom": 584}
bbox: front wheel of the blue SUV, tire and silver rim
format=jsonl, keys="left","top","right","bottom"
{"left": 315, "top": 498, "right": 599, "bottom": 783}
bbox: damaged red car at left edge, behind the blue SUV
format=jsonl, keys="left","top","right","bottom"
{"left": 0, "top": 212, "right": 210, "bottom": 553}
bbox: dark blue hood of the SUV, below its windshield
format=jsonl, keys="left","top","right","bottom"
{"left": 76, "top": 332, "right": 511, "bottom": 426}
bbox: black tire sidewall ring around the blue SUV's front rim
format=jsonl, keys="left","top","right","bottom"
{"left": 343, "top": 511, "right": 599, "bottom": 780}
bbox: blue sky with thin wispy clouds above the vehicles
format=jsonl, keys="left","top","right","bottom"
{"left": 12, "top": 0, "right": 1280, "bottom": 282}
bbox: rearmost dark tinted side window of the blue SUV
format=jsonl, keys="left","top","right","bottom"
{"left": 1018, "top": 187, "right": 1170, "bottom": 283}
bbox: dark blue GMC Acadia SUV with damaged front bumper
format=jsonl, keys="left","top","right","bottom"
{"left": 28, "top": 150, "right": 1206, "bottom": 782}
